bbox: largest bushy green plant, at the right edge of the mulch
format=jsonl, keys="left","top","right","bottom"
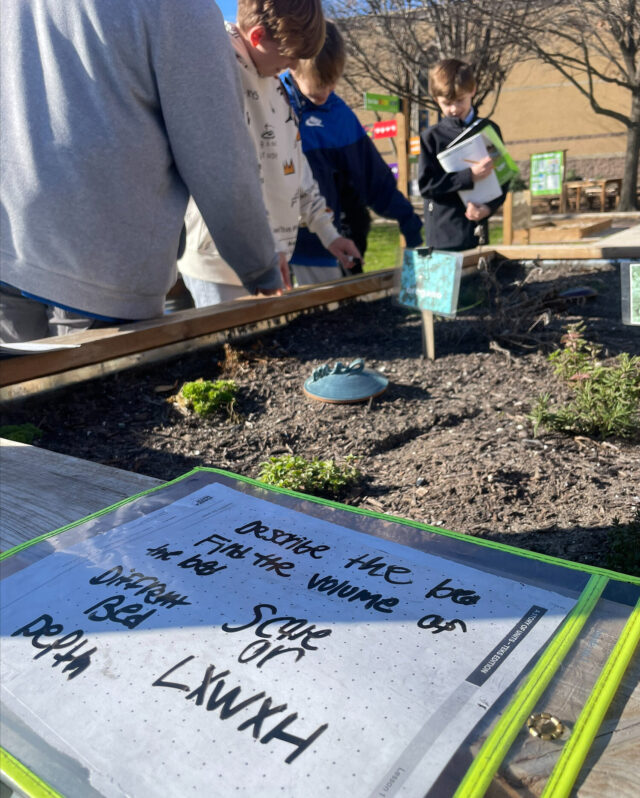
{"left": 529, "top": 322, "right": 640, "bottom": 438}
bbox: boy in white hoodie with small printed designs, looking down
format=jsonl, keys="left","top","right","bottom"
{"left": 178, "top": 0, "right": 360, "bottom": 307}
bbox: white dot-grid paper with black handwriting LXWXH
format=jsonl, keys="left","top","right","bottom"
{"left": 0, "top": 484, "right": 574, "bottom": 798}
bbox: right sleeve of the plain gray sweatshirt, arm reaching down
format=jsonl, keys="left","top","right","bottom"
{"left": 151, "top": 0, "right": 282, "bottom": 293}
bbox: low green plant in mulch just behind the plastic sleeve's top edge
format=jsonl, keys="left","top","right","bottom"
{"left": 259, "top": 454, "right": 362, "bottom": 499}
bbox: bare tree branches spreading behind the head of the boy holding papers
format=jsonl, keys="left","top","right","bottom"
{"left": 325, "top": 0, "right": 536, "bottom": 113}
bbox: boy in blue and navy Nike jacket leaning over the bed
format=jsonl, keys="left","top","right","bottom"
{"left": 281, "top": 20, "right": 422, "bottom": 284}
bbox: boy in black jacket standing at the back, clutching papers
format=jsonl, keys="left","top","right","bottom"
{"left": 418, "top": 58, "right": 508, "bottom": 251}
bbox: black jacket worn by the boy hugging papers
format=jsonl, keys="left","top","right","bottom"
{"left": 418, "top": 111, "right": 508, "bottom": 252}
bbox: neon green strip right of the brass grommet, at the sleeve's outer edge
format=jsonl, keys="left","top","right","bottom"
{"left": 541, "top": 600, "right": 640, "bottom": 798}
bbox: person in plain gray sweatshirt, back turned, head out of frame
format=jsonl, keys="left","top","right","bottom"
{"left": 0, "top": 0, "right": 282, "bottom": 342}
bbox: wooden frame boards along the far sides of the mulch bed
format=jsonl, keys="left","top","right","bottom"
{"left": 0, "top": 238, "right": 640, "bottom": 400}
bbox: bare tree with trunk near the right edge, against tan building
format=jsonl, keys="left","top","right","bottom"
{"left": 492, "top": 0, "right": 640, "bottom": 211}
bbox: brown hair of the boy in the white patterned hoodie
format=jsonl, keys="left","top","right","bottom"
{"left": 237, "top": 0, "right": 324, "bottom": 58}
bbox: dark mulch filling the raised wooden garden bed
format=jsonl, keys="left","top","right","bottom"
{"left": 1, "top": 263, "right": 640, "bottom": 565}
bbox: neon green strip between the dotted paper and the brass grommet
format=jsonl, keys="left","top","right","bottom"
{"left": 454, "top": 574, "right": 609, "bottom": 798}
